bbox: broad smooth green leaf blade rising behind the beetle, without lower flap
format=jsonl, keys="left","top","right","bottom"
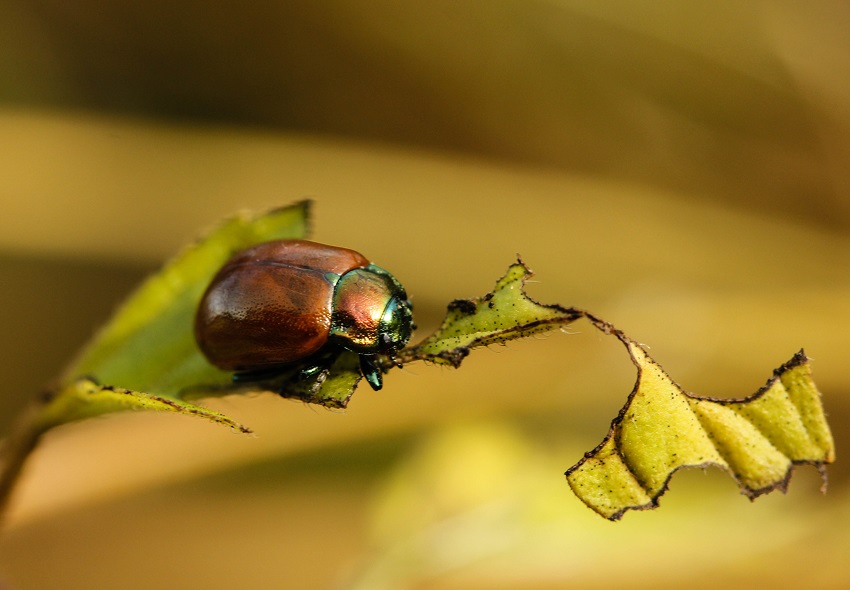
{"left": 61, "top": 201, "right": 309, "bottom": 399}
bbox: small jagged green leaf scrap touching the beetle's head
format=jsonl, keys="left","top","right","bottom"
{"left": 399, "top": 261, "right": 582, "bottom": 367}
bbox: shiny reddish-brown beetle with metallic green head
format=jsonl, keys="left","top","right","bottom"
{"left": 195, "top": 240, "right": 415, "bottom": 391}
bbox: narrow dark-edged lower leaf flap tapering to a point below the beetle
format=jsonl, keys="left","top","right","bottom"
{"left": 38, "top": 378, "right": 251, "bottom": 433}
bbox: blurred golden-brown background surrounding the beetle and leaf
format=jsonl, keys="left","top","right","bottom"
{"left": 0, "top": 0, "right": 850, "bottom": 590}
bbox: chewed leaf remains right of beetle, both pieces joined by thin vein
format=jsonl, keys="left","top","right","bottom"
{"left": 400, "top": 261, "right": 833, "bottom": 520}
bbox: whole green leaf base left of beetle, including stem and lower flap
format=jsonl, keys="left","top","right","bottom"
{"left": 0, "top": 207, "right": 310, "bottom": 516}
